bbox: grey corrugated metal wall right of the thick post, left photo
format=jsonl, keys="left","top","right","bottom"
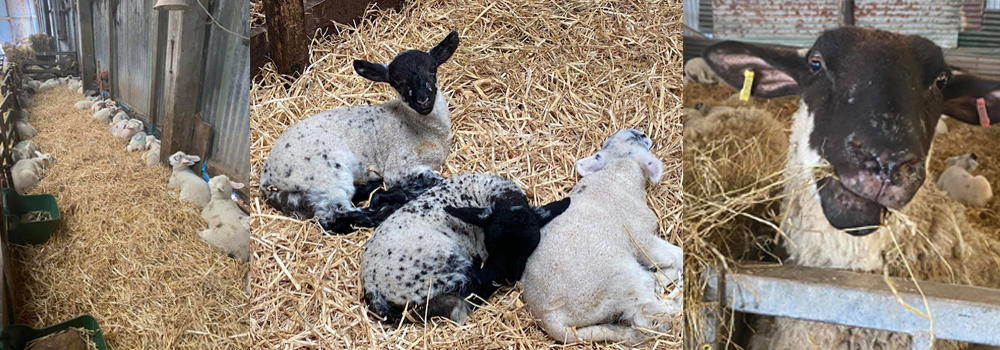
{"left": 192, "top": 0, "right": 250, "bottom": 179}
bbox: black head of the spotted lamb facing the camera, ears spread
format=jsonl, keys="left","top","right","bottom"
{"left": 354, "top": 32, "right": 458, "bottom": 115}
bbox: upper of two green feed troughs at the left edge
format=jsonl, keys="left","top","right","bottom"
{"left": 3, "top": 188, "right": 59, "bottom": 245}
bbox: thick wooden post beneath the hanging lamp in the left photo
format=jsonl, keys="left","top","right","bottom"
{"left": 160, "top": 4, "right": 208, "bottom": 163}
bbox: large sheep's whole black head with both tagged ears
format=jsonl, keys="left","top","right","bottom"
{"left": 705, "top": 27, "right": 1000, "bottom": 235}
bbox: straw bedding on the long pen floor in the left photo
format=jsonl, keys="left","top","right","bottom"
{"left": 11, "top": 86, "right": 249, "bottom": 350}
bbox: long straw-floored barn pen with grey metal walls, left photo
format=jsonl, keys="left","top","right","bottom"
{"left": 0, "top": 0, "right": 250, "bottom": 349}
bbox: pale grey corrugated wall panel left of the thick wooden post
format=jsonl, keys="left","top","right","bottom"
{"left": 112, "top": 0, "right": 158, "bottom": 118}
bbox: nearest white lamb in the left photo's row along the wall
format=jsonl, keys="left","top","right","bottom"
{"left": 198, "top": 175, "right": 250, "bottom": 261}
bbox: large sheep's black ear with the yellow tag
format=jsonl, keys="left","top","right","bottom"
{"left": 704, "top": 41, "right": 809, "bottom": 98}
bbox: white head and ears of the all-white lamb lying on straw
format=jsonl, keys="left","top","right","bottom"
{"left": 576, "top": 129, "right": 663, "bottom": 183}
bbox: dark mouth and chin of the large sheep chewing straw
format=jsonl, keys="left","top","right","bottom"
{"left": 816, "top": 176, "right": 887, "bottom": 236}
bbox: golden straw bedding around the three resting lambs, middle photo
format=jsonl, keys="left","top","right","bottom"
{"left": 251, "top": 0, "right": 682, "bottom": 349}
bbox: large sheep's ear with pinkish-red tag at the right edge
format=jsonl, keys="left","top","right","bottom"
{"left": 942, "top": 74, "right": 1000, "bottom": 125}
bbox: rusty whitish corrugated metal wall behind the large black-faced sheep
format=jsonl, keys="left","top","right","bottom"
{"left": 713, "top": 0, "right": 961, "bottom": 48}
